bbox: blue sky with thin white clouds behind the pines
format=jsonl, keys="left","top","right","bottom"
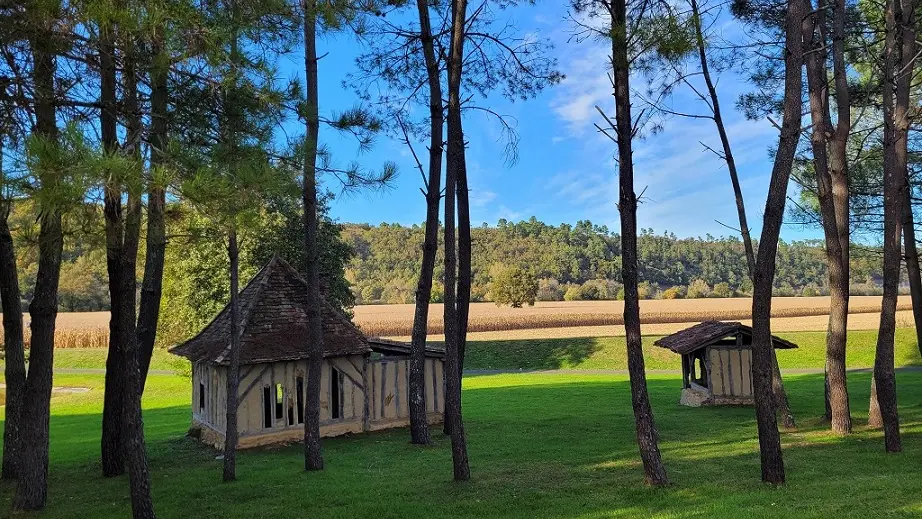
{"left": 283, "top": 2, "right": 819, "bottom": 239}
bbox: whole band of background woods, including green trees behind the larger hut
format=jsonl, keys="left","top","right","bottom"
{"left": 11, "top": 213, "right": 880, "bottom": 314}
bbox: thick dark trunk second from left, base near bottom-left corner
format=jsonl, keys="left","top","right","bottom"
{"left": 13, "top": 7, "right": 63, "bottom": 510}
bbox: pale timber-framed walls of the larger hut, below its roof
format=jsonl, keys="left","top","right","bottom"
{"left": 190, "top": 354, "right": 445, "bottom": 449}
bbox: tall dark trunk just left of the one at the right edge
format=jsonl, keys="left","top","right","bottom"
{"left": 870, "top": 0, "right": 916, "bottom": 452}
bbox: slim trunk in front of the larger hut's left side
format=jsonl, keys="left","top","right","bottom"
{"left": 224, "top": 230, "right": 240, "bottom": 481}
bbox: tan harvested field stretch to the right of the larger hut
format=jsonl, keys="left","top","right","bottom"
{"left": 355, "top": 296, "right": 912, "bottom": 339}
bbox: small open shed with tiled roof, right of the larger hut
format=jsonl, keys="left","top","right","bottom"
{"left": 653, "top": 321, "right": 797, "bottom": 407}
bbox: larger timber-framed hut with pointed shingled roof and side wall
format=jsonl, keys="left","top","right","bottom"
{"left": 170, "top": 257, "right": 445, "bottom": 448}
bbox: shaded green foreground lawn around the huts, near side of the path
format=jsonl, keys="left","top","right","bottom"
{"left": 0, "top": 371, "right": 922, "bottom": 519}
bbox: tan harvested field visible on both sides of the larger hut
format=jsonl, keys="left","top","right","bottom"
{"left": 0, "top": 296, "right": 913, "bottom": 348}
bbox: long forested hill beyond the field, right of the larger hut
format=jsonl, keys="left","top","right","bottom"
{"left": 342, "top": 217, "right": 880, "bottom": 303}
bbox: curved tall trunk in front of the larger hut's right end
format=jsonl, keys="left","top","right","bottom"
{"left": 410, "top": 0, "right": 444, "bottom": 445}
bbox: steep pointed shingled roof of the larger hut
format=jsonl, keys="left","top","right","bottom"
{"left": 170, "top": 256, "right": 371, "bottom": 364}
